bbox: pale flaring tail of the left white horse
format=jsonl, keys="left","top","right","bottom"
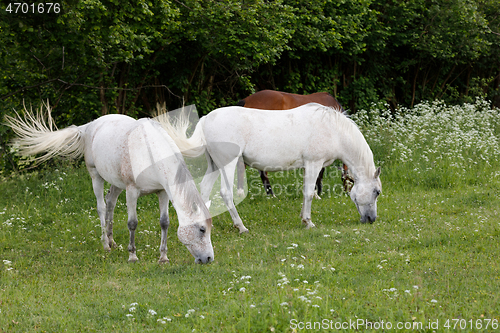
{"left": 5, "top": 104, "right": 86, "bottom": 162}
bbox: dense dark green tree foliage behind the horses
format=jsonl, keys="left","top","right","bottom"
{"left": 0, "top": 0, "right": 500, "bottom": 170}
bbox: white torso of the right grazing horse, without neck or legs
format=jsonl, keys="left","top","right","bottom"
{"left": 203, "top": 104, "right": 335, "bottom": 171}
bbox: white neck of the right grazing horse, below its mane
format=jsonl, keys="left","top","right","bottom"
{"left": 337, "top": 120, "right": 375, "bottom": 180}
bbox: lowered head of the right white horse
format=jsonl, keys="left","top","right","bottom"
{"left": 350, "top": 167, "right": 382, "bottom": 223}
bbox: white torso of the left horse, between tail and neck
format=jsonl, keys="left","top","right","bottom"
{"left": 85, "top": 115, "right": 180, "bottom": 191}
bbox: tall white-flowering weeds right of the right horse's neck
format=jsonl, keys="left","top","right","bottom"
{"left": 353, "top": 99, "right": 500, "bottom": 188}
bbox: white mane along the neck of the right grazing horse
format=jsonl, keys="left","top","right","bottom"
{"left": 317, "top": 105, "right": 375, "bottom": 174}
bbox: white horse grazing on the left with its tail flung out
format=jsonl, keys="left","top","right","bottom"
{"left": 6, "top": 106, "right": 214, "bottom": 263}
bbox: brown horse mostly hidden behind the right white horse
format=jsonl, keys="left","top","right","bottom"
{"left": 236, "top": 90, "right": 349, "bottom": 196}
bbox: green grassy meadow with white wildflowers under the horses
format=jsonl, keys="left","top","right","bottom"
{"left": 0, "top": 100, "right": 500, "bottom": 332}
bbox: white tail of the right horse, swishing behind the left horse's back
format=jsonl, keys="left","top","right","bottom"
{"left": 154, "top": 108, "right": 206, "bottom": 157}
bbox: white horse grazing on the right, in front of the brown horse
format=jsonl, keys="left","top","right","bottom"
{"left": 162, "top": 103, "right": 382, "bottom": 233}
